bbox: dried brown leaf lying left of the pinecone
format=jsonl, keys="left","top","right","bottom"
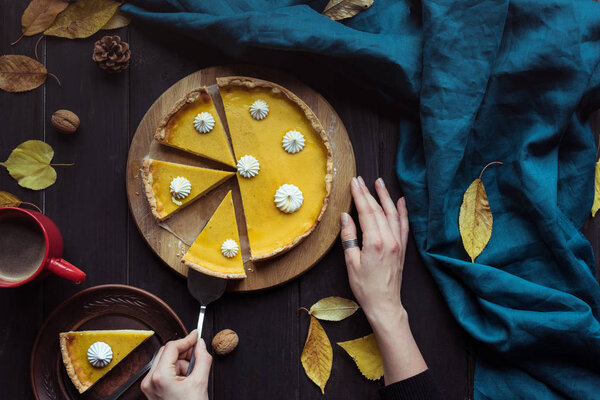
{"left": 0, "top": 54, "right": 48, "bottom": 92}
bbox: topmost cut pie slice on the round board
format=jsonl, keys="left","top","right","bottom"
{"left": 154, "top": 87, "right": 235, "bottom": 167}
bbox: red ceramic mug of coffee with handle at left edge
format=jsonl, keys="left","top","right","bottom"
{"left": 0, "top": 207, "right": 85, "bottom": 287}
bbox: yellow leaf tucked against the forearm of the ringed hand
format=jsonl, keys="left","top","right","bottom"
{"left": 338, "top": 333, "right": 383, "bottom": 381}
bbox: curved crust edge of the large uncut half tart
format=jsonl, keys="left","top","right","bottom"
{"left": 217, "top": 76, "right": 333, "bottom": 261}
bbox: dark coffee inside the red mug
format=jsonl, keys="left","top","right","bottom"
{"left": 0, "top": 214, "right": 46, "bottom": 282}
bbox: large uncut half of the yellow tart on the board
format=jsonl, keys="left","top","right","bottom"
{"left": 217, "top": 76, "right": 333, "bottom": 260}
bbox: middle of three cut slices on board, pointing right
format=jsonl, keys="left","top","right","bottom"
{"left": 142, "top": 158, "right": 233, "bottom": 221}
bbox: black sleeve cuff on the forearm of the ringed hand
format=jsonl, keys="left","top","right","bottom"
{"left": 379, "top": 370, "right": 442, "bottom": 400}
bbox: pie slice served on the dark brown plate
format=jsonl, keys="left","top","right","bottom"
{"left": 59, "top": 329, "right": 154, "bottom": 393}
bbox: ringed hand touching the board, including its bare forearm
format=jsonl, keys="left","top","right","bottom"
{"left": 341, "top": 177, "right": 427, "bottom": 385}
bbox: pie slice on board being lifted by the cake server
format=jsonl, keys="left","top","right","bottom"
{"left": 182, "top": 191, "right": 246, "bottom": 279}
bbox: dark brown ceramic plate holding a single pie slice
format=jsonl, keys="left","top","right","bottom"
{"left": 31, "top": 285, "right": 187, "bottom": 400}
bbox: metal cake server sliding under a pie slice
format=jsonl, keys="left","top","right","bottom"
{"left": 187, "top": 268, "right": 227, "bottom": 375}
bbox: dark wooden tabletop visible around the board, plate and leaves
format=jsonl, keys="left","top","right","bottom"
{"left": 0, "top": 0, "right": 600, "bottom": 400}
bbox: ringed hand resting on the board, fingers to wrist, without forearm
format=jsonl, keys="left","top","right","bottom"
{"left": 341, "top": 177, "right": 409, "bottom": 328}
